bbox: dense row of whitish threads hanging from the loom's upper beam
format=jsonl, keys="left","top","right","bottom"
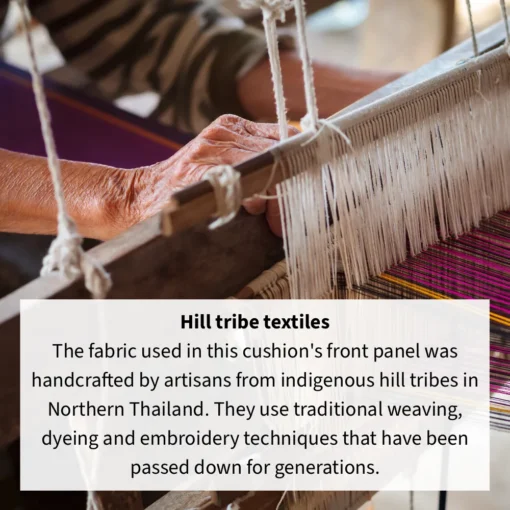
{"left": 280, "top": 59, "right": 510, "bottom": 299}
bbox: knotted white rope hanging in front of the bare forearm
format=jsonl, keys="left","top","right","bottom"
{"left": 18, "top": 0, "right": 111, "bottom": 299}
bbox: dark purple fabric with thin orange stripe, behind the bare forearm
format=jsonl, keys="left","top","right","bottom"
{"left": 0, "top": 63, "right": 191, "bottom": 168}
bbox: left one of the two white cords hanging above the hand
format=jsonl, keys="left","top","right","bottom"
{"left": 239, "top": 0, "right": 292, "bottom": 140}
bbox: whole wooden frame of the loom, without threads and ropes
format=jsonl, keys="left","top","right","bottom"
{"left": 0, "top": 15, "right": 505, "bottom": 510}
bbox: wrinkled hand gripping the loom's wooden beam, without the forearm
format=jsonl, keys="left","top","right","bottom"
{"left": 129, "top": 115, "right": 298, "bottom": 235}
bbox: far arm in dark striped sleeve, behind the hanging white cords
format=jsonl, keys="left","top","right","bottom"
{"left": 15, "top": 0, "right": 395, "bottom": 132}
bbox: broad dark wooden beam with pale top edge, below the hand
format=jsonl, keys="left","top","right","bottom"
{"left": 0, "top": 212, "right": 283, "bottom": 446}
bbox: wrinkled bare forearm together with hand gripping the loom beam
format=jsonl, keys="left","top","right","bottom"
{"left": 0, "top": 115, "right": 288, "bottom": 239}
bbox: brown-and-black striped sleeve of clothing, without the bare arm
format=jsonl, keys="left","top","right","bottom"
{"left": 0, "top": 0, "right": 272, "bottom": 132}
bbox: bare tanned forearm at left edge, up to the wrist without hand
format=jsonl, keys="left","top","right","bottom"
{"left": 0, "top": 149, "right": 134, "bottom": 239}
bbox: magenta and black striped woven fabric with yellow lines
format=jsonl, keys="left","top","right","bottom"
{"left": 236, "top": 211, "right": 510, "bottom": 430}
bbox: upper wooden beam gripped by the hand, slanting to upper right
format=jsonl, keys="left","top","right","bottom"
{"left": 162, "top": 17, "right": 505, "bottom": 237}
